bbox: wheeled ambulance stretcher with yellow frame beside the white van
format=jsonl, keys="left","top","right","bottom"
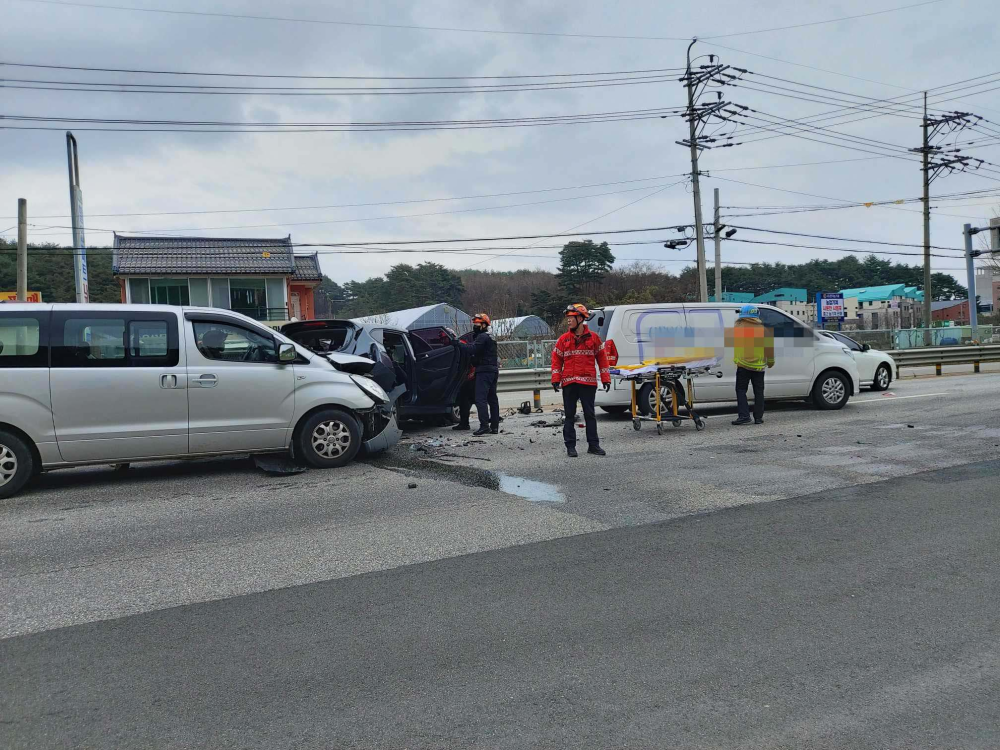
{"left": 611, "top": 358, "right": 722, "bottom": 435}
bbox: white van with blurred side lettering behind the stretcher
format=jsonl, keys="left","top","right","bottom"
{"left": 589, "top": 302, "right": 860, "bottom": 414}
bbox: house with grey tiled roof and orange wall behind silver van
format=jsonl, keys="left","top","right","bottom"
{"left": 112, "top": 234, "right": 323, "bottom": 327}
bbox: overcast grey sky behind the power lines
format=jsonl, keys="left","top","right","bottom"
{"left": 0, "top": 0, "right": 1000, "bottom": 282}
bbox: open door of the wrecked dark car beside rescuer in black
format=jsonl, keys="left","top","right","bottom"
{"left": 407, "top": 326, "right": 469, "bottom": 409}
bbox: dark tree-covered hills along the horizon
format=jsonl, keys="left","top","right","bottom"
{"left": 0, "top": 240, "right": 966, "bottom": 325}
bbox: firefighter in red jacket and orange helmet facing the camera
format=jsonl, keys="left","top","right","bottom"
{"left": 552, "top": 305, "right": 611, "bottom": 458}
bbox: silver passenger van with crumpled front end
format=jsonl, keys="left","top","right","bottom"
{"left": 0, "top": 303, "right": 401, "bottom": 498}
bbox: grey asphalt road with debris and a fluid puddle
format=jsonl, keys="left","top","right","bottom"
{"left": 0, "top": 374, "right": 1000, "bottom": 748}
